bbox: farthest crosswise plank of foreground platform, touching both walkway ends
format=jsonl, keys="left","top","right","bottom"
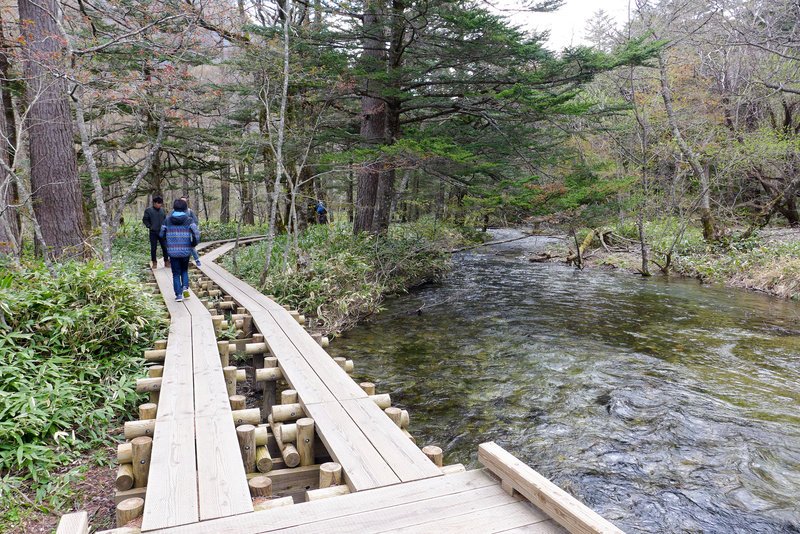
{"left": 144, "top": 470, "right": 497, "bottom": 534}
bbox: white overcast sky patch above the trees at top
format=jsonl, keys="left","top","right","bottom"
{"left": 506, "top": 0, "right": 628, "bottom": 50}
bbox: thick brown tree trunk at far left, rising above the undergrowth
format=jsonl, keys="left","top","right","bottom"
{"left": 18, "top": 0, "right": 87, "bottom": 257}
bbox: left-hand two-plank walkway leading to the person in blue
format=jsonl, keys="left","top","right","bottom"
{"left": 142, "top": 260, "right": 253, "bottom": 531}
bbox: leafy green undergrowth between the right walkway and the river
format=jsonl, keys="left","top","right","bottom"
{"left": 224, "top": 219, "right": 482, "bottom": 333}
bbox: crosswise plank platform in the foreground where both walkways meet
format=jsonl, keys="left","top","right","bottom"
{"left": 144, "top": 470, "right": 567, "bottom": 534}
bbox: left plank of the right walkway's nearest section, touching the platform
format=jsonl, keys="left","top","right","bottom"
{"left": 305, "top": 403, "right": 400, "bottom": 491}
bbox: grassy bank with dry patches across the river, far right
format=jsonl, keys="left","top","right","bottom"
{"left": 551, "top": 219, "right": 800, "bottom": 300}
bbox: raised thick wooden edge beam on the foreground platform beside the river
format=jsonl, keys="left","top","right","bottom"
{"left": 478, "top": 442, "right": 624, "bottom": 534}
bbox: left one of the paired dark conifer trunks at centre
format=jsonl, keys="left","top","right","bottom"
{"left": 353, "top": 0, "right": 386, "bottom": 234}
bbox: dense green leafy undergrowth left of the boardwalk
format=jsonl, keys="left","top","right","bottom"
{"left": 0, "top": 262, "right": 166, "bottom": 531}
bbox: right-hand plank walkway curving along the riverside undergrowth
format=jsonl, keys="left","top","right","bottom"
{"left": 196, "top": 243, "right": 442, "bottom": 491}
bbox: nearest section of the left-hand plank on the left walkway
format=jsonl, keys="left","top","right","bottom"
{"left": 142, "top": 416, "right": 199, "bottom": 531}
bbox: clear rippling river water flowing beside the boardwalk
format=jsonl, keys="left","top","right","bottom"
{"left": 329, "top": 230, "right": 800, "bottom": 534}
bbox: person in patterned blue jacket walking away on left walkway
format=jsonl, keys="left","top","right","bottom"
{"left": 160, "top": 199, "right": 200, "bottom": 302}
